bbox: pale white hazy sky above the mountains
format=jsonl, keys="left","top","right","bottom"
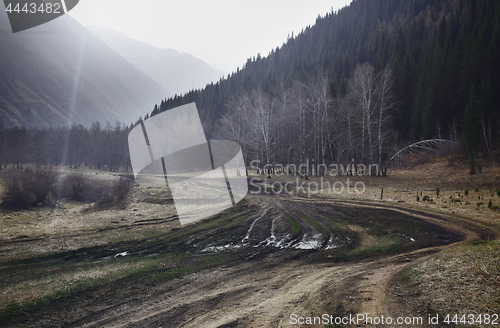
{"left": 69, "top": 0, "right": 351, "bottom": 71}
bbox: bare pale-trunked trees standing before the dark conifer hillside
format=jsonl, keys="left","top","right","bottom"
{"left": 217, "top": 63, "right": 396, "bottom": 174}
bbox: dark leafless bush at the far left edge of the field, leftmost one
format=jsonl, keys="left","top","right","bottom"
{"left": 2, "top": 165, "right": 57, "bottom": 210}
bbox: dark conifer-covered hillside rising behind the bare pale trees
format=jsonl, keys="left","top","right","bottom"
{"left": 152, "top": 0, "right": 500, "bottom": 169}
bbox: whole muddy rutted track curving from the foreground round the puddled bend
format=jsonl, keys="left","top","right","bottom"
{"left": 6, "top": 196, "right": 496, "bottom": 328}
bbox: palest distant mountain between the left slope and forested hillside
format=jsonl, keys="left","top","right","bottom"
{"left": 88, "top": 26, "right": 224, "bottom": 95}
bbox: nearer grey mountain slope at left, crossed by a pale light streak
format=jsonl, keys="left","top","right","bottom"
{"left": 0, "top": 11, "right": 170, "bottom": 127}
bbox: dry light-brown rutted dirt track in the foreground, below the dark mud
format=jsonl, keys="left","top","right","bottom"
{"left": 55, "top": 249, "right": 446, "bottom": 327}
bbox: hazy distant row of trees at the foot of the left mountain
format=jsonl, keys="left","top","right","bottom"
{"left": 0, "top": 122, "right": 134, "bottom": 171}
